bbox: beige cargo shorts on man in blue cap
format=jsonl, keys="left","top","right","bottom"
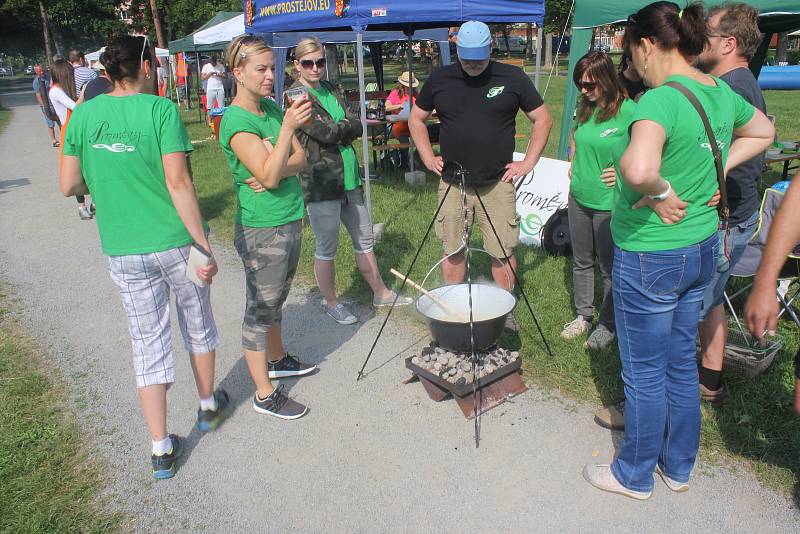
{"left": 436, "top": 181, "right": 519, "bottom": 259}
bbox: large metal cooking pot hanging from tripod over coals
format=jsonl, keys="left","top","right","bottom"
{"left": 417, "top": 284, "right": 517, "bottom": 352}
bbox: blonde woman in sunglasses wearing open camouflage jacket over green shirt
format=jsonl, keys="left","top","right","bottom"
{"left": 292, "top": 37, "right": 412, "bottom": 324}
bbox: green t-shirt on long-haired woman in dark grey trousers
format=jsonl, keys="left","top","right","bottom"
{"left": 569, "top": 98, "right": 636, "bottom": 211}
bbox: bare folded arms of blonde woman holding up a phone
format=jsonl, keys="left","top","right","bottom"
{"left": 231, "top": 100, "right": 311, "bottom": 189}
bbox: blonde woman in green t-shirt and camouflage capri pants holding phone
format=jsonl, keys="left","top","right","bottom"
{"left": 219, "top": 36, "right": 316, "bottom": 419}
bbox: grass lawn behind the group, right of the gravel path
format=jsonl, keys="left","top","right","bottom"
{"left": 183, "top": 63, "right": 800, "bottom": 502}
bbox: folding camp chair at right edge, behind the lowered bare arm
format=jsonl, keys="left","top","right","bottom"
{"left": 724, "top": 181, "right": 800, "bottom": 336}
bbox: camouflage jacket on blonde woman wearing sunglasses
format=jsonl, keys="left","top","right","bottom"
{"left": 292, "top": 80, "right": 361, "bottom": 202}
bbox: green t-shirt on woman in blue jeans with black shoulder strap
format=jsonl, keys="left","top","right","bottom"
{"left": 611, "top": 76, "right": 755, "bottom": 252}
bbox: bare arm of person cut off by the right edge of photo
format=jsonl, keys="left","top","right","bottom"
{"left": 744, "top": 172, "right": 800, "bottom": 415}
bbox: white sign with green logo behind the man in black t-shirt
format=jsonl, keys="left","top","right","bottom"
{"left": 514, "top": 152, "right": 571, "bottom": 247}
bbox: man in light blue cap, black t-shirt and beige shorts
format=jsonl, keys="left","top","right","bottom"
{"left": 408, "top": 21, "right": 553, "bottom": 330}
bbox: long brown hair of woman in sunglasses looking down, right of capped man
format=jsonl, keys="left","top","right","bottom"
{"left": 572, "top": 52, "right": 626, "bottom": 124}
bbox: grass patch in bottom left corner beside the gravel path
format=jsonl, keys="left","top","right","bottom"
{"left": 0, "top": 288, "right": 121, "bottom": 533}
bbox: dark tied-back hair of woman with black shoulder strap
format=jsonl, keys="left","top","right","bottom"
{"left": 622, "top": 2, "right": 708, "bottom": 59}
